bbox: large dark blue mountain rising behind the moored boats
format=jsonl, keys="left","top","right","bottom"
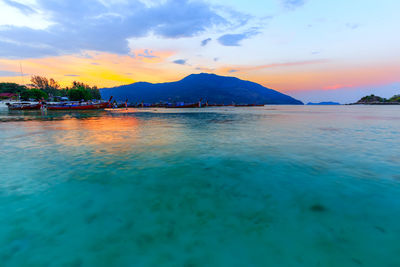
{"left": 100, "top": 73, "right": 303, "bottom": 105}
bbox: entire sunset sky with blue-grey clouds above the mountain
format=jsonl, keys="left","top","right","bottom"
{"left": 0, "top": 0, "right": 400, "bottom": 103}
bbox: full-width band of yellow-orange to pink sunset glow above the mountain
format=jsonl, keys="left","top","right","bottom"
{"left": 0, "top": 49, "right": 400, "bottom": 92}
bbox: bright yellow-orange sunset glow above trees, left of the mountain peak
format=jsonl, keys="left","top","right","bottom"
{"left": 0, "top": 50, "right": 173, "bottom": 88}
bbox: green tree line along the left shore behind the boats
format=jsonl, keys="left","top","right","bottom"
{"left": 0, "top": 75, "right": 101, "bottom": 101}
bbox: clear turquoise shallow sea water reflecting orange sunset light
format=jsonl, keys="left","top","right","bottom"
{"left": 0, "top": 106, "right": 400, "bottom": 266}
